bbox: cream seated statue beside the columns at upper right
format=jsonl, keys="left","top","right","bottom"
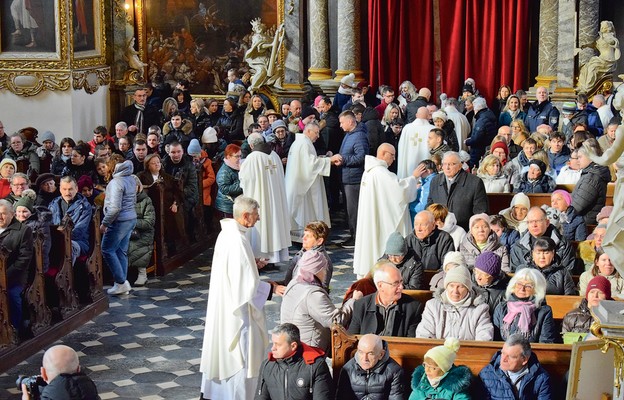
{"left": 577, "top": 21, "right": 621, "bottom": 93}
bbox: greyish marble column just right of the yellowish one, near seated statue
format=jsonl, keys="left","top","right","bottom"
{"left": 555, "top": 0, "right": 576, "bottom": 93}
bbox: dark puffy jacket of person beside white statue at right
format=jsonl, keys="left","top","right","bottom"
{"left": 572, "top": 162, "right": 611, "bottom": 225}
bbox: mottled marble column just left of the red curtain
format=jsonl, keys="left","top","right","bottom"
{"left": 335, "top": 0, "right": 364, "bottom": 81}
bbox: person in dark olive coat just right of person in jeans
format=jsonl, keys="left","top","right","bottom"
{"left": 128, "top": 175, "right": 156, "bottom": 286}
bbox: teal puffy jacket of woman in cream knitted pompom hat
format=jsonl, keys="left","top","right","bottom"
{"left": 409, "top": 365, "right": 472, "bottom": 400}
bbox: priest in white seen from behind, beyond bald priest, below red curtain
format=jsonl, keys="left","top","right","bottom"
{"left": 397, "top": 107, "right": 435, "bottom": 179}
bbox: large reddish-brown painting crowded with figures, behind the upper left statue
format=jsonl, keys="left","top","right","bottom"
{"left": 145, "top": 0, "right": 283, "bottom": 96}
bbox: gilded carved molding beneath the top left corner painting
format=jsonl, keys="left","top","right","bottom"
{"left": 0, "top": 71, "right": 70, "bottom": 97}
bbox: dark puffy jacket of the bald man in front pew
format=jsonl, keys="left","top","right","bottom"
{"left": 336, "top": 340, "right": 405, "bottom": 400}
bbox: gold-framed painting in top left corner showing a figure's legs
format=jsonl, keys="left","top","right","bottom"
{"left": 0, "top": 0, "right": 60, "bottom": 59}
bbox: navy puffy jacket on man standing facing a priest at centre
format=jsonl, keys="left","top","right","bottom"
{"left": 340, "top": 124, "right": 368, "bottom": 185}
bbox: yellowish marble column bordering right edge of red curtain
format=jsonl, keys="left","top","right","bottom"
{"left": 535, "top": 0, "right": 566, "bottom": 89}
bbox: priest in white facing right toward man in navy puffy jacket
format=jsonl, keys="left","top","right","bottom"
{"left": 284, "top": 121, "right": 342, "bottom": 242}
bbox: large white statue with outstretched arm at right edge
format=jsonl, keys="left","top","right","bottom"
{"left": 584, "top": 80, "right": 624, "bottom": 275}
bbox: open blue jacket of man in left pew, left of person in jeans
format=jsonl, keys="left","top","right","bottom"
{"left": 48, "top": 193, "right": 93, "bottom": 255}
